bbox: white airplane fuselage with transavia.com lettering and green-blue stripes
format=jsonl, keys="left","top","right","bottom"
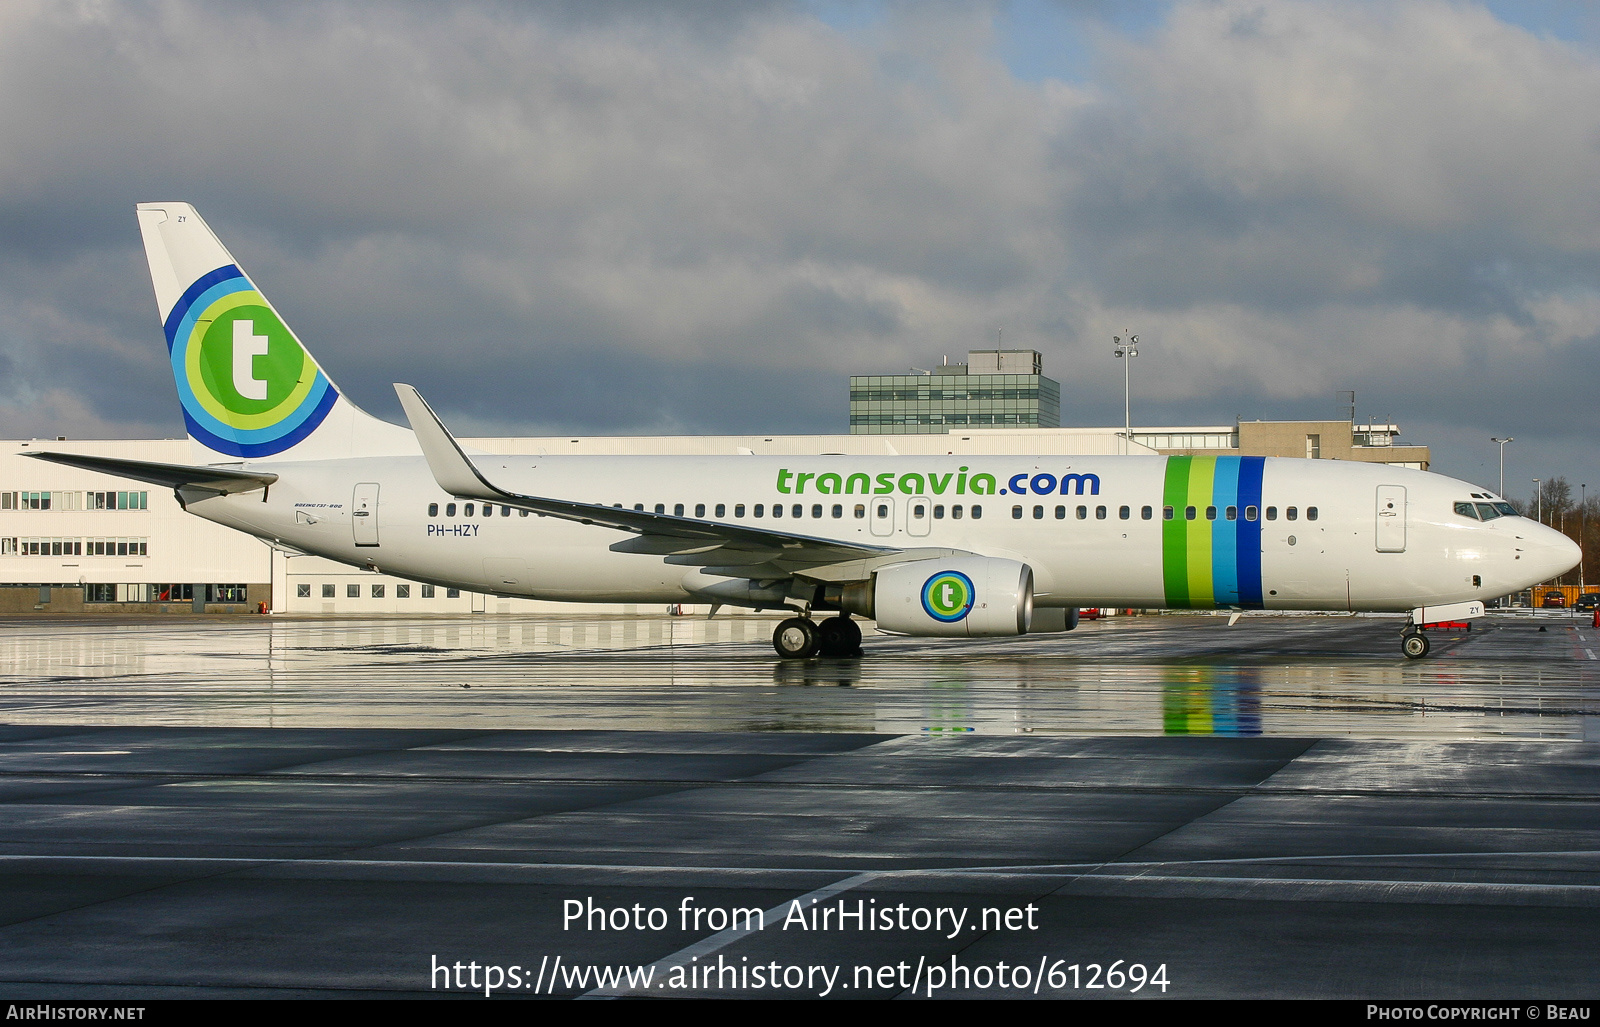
{"left": 189, "top": 454, "right": 1578, "bottom": 611}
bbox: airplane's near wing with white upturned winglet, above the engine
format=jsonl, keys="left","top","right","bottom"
{"left": 395, "top": 384, "right": 950, "bottom": 577}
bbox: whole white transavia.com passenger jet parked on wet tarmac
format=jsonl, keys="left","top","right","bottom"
{"left": 18, "top": 202, "right": 1579, "bottom": 659}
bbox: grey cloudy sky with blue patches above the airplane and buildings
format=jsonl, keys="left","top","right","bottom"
{"left": 0, "top": 0, "right": 1600, "bottom": 496}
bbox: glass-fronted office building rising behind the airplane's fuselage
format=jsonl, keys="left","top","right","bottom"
{"left": 850, "top": 350, "right": 1061, "bottom": 435}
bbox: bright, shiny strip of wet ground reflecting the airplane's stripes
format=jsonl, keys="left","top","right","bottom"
{"left": 0, "top": 614, "right": 1600, "bottom": 739}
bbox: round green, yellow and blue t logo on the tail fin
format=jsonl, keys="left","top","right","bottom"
{"left": 166, "top": 266, "right": 339, "bottom": 458}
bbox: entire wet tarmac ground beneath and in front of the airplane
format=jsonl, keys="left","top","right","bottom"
{"left": 0, "top": 616, "right": 1600, "bottom": 1001}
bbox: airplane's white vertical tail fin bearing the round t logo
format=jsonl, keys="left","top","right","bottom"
{"left": 138, "top": 203, "right": 418, "bottom": 462}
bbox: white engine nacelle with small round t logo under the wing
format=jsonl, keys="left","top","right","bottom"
{"left": 872, "top": 557, "right": 1034, "bottom": 638}
